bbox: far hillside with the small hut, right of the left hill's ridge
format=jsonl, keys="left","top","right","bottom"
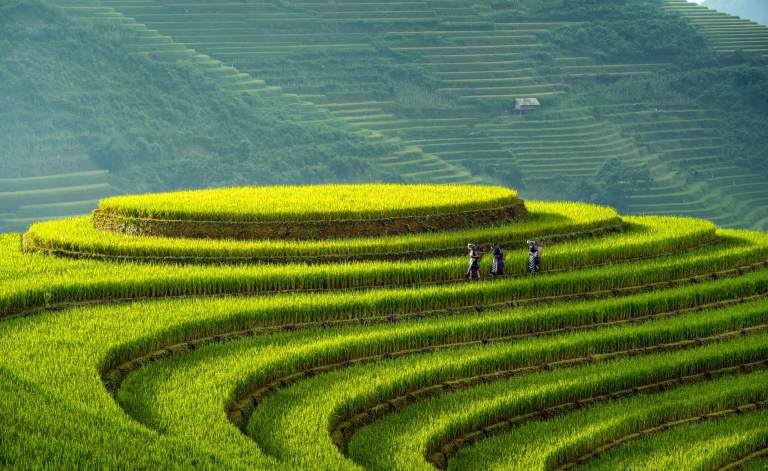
{"left": 27, "top": 0, "right": 768, "bottom": 230}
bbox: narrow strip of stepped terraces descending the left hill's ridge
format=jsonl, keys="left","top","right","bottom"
{"left": 45, "top": 0, "right": 492, "bottom": 189}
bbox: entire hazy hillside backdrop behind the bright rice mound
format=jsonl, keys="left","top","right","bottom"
{"left": 0, "top": 0, "right": 768, "bottom": 231}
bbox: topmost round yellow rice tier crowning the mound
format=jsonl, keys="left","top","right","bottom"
{"left": 99, "top": 184, "right": 517, "bottom": 222}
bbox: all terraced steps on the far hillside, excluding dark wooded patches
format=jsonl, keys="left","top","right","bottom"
{"left": 40, "top": 0, "right": 768, "bottom": 231}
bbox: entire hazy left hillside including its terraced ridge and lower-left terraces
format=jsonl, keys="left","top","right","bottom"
{"left": 0, "top": 0, "right": 408, "bottom": 232}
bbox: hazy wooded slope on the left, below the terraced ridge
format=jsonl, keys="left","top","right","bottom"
{"left": 0, "top": 0, "right": 387, "bottom": 192}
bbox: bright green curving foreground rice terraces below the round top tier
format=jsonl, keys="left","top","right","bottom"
{"left": 0, "top": 187, "right": 768, "bottom": 471}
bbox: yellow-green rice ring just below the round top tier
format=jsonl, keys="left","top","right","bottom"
{"left": 29, "top": 201, "right": 619, "bottom": 258}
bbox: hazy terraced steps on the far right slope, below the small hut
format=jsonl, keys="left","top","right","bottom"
{"left": 496, "top": 104, "right": 768, "bottom": 231}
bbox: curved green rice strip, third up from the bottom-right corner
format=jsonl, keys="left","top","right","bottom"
{"left": 443, "top": 371, "right": 768, "bottom": 471}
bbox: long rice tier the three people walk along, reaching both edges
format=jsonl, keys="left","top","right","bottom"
{"left": 0, "top": 220, "right": 768, "bottom": 315}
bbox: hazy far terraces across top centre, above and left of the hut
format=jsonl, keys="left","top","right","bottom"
{"left": 76, "top": 0, "right": 663, "bottom": 177}
